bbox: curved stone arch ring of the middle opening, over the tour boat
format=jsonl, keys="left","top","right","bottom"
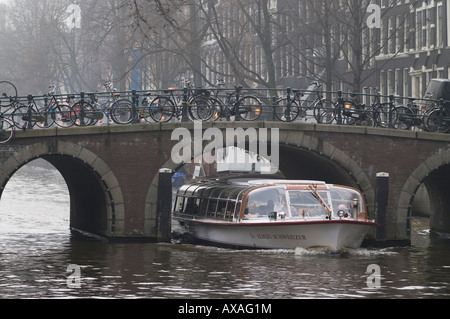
{"left": 145, "top": 130, "right": 375, "bottom": 229}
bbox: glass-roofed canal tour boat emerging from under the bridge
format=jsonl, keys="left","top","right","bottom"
{"left": 173, "top": 179, "right": 377, "bottom": 252}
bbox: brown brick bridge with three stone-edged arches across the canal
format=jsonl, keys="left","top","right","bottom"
{"left": 0, "top": 122, "right": 450, "bottom": 243}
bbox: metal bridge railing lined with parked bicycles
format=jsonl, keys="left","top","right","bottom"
{"left": 0, "top": 83, "right": 450, "bottom": 132}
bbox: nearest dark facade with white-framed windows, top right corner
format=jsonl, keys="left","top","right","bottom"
{"left": 376, "top": 0, "right": 450, "bottom": 97}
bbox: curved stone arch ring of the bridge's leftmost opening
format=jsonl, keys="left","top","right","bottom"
{"left": 0, "top": 141, "right": 124, "bottom": 237}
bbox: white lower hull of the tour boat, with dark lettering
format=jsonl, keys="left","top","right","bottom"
{"left": 176, "top": 219, "right": 376, "bottom": 251}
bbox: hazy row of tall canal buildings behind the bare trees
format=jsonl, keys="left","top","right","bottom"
{"left": 195, "top": 0, "right": 450, "bottom": 97}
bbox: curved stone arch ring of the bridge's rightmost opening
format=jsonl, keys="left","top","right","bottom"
{"left": 397, "top": 150, "right": 450, "bottom": 235}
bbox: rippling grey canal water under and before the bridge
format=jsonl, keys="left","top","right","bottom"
{"left": 0, "top": 163, "right": 450, "bottom": 302}
